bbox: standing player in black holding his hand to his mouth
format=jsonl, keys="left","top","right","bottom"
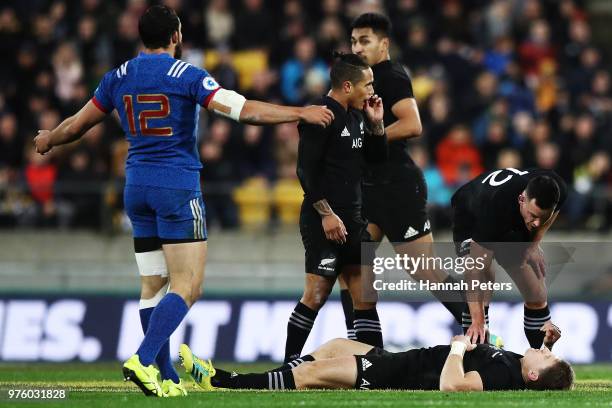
{"left": 285, "top": 54, "right": 387, "bottom": 361}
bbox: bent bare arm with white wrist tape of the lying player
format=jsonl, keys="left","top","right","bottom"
{"left": 440, "top": 336, "right": 484, "bottom": 392}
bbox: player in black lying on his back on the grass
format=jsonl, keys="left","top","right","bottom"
{"left": 179, "top": 325, "right": 574, "bottom": 391}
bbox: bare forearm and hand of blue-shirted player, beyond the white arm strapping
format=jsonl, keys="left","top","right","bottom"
{"left": 239, "top": 100, "right": 334, "bottom": 127}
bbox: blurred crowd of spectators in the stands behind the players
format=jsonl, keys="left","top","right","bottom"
{"left": 0, "top": 0, "right": 612, "bottom": 231}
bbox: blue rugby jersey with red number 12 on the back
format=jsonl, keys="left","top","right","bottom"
{"left": 92, "top": 53, "right": 220, "bottom": 190}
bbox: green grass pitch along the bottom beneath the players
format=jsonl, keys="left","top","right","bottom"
{"left": 0, "top": 363, "right": 612, "bottom": 408}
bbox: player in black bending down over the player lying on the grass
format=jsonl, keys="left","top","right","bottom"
{"left": 451, "top": 168, "right": 567, "bottom": 348}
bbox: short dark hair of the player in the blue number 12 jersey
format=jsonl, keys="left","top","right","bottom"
{"left": 138, "top": 5, "right": 180, "bottom": 49}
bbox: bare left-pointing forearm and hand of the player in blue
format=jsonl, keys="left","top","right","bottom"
{"left": 34, "top": 101, "right": 106, "bottom": 154}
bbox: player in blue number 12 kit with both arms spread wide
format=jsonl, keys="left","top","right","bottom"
{"left": 34, "top": 6, "right": 333, "bottom": 397}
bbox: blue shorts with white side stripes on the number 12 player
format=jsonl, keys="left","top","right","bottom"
{"left": 123, "top": 185, "right": 207, "bottom": 241}
